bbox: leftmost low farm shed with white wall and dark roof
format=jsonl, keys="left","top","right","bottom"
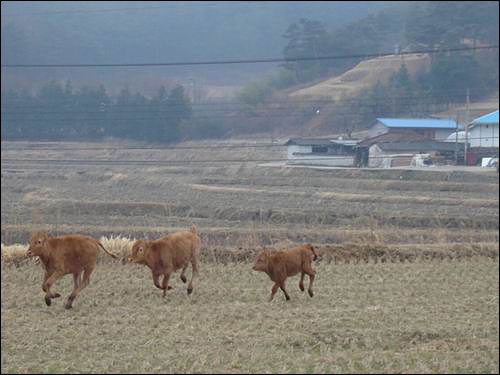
{"left": 285, "top": 138, "right": 358, "bottom": 167}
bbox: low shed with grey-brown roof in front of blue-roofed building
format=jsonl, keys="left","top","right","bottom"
{"left": 368, "top": 140, "right": 462, "bottom": 168}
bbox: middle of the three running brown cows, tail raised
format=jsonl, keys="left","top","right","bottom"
{"left": 129, "top": 225, "right": 201, "bottom": 297}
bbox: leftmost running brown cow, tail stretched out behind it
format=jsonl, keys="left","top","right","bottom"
{"left": 27, "top": 232, "right": 117, "bottom": 309}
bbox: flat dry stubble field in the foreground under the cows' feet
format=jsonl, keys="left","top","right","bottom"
{"left": 1, "top": 258, "right": 499, "bottom": 373}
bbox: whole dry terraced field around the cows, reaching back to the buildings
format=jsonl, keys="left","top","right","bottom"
{"left": 1, "top": 142, "right": 499, "bottom": 373}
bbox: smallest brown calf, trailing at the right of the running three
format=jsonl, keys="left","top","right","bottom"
{"left": 253, "top": 244, "right": 318, "bottom": 302}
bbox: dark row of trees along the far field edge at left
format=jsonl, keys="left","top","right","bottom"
{"left": 1, "top": 81, "right": 192, "bottom": 143}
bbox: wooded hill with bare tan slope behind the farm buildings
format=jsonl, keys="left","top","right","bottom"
{"left": 240, "top": 1, "right": 499, "bottom": 135}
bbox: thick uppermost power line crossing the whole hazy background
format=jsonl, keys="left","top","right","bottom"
{"left": 1, "top": 45, "right": 498, "bottom": 68}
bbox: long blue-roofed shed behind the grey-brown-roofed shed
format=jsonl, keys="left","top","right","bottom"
{"left": 368, "top": 118, "right": 457, "bottom": 140}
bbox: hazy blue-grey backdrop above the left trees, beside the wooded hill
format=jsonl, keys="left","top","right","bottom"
{"left": 1, "top": 1, "right": 391, "bottom": 93}
